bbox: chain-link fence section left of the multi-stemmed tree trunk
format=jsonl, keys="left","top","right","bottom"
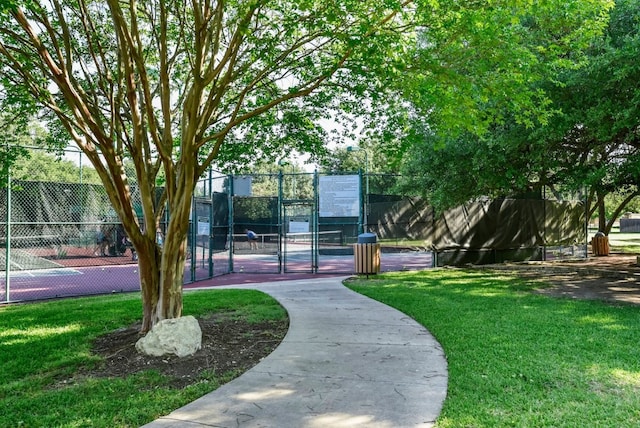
{"left": 0, "top": 177, "right": 139, "bottom": 301}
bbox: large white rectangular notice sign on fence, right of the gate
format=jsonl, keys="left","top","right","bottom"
{"left": 318, "top": 175, "right": 360, "bottom": 217}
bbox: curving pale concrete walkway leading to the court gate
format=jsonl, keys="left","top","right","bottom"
{"left": 145, "top": 278, "right": 447, "bottom": 428}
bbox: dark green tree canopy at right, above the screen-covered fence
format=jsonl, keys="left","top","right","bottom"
{"left": 404, "top": 0, "right": 640, "bottom": 231}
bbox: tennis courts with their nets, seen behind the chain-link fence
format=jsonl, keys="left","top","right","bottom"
{"left": 0, "top": 239, "right": 433, "bottom": 302}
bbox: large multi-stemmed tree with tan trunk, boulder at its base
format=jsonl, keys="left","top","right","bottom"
{"left": 0, "top": 0, "right": 609, "bottom": 333}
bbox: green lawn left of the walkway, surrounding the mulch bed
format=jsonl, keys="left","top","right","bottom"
{"left": 0, "top": 290, "right": 286, "bottom": 428}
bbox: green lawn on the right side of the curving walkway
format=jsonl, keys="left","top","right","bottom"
{"left": 348, "top": 269, "right": 640, "bottom": 428}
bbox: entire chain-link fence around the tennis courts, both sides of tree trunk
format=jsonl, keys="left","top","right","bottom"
{"left": 0, "top": 147, "right": 587, "bottom": 301}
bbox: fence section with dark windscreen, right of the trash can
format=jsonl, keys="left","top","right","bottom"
{"left": 365, "top": 175, "right": 587, "bottom": 266}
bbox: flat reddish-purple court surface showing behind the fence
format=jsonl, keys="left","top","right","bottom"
{"left": 0, "top": 252, "right": 433, "bottom": 303}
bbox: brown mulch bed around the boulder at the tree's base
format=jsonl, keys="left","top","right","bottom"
{"left": 84, "top": 316, "right": 288, "bottom": 388}
